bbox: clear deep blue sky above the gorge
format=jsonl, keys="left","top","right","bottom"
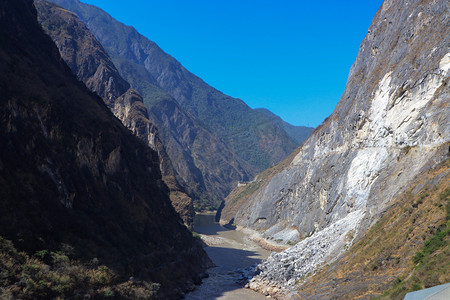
{"left": 81, "top": 0, "right": 383, "bottom": 127}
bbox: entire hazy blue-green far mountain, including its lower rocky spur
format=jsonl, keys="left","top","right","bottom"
{"left": 47, "top": 0, "right": 312, "bottom": 209}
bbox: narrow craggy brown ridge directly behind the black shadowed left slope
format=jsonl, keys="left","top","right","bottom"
{"left": 34, "top": 0, "right": 194, "bottom": 227}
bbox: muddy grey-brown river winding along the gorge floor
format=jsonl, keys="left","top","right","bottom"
{"left": 186, "top": 213, "right": 270, "bottom": 300}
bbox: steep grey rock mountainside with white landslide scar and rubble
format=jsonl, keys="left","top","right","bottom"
{"left": 222, "top": 0, "right": 450, "bottom": 299}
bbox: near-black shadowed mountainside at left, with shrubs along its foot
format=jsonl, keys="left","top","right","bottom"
{"left": 0, "top": 0, "right": 209, "bottom": 299}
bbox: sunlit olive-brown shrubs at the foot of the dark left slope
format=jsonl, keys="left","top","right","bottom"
{"left": 0, "top": 237, "right": 159, "bottom": 299}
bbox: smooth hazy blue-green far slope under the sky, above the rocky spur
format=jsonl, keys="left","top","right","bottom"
{"left": 46, "top": 0, "right": 312, "bottom": 204}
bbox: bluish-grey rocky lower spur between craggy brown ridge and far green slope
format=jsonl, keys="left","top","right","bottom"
{"left": 150, "top": 101, "right": 251, "bottom": 209}
